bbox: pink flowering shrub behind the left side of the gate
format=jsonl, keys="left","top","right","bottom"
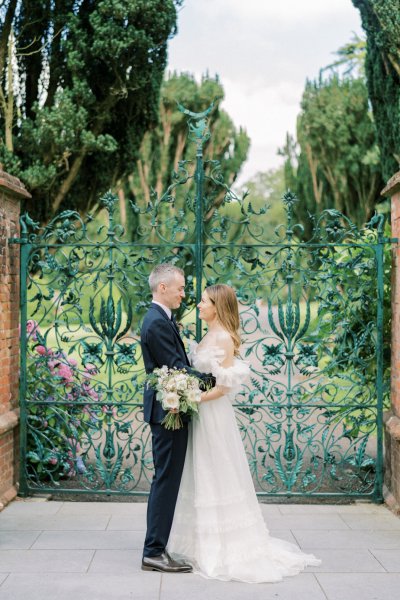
{"left": 27, "top": 320, "right": 104, "bottom": 481}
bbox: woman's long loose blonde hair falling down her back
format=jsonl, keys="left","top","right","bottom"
{"left": 205, "top": 283, "right": 240, "bottom": 356}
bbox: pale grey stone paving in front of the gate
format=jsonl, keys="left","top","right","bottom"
{"left": 0, "top": 500, "right": 400, "bottom": 600}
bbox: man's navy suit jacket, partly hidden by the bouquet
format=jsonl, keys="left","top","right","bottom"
{"left": 140, "top": 303, "right": 208, "bottom": 423}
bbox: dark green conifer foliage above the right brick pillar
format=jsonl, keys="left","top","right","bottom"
{"left": 353, "top": 0, "right": 400, "bottom": 180}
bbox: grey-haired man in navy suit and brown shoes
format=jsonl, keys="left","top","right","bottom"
{"left": 140, "top": 263, "right": 215, "bottom": 573}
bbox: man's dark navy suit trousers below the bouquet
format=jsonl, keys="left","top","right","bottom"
{"left": 143, "top": 422, "right": 188, "bottom": 556}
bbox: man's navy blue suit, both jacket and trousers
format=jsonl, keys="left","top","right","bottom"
{"left": 140, "top": 304, "right": 207, "bottom": 556}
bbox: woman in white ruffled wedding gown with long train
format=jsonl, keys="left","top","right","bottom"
{"left": 167, "top": 284, "right": 320, "bottom": 583}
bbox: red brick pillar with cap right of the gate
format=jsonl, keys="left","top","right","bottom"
{"left": 382, "top": 171, "right": 400, "bottom": 509}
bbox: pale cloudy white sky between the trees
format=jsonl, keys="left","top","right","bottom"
{"left": 168, "top": 0, "right": 365, "bottom": 184}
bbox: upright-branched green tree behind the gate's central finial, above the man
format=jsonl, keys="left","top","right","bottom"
{"left": 111, "top": 73, "right": 250, "bottom": 324}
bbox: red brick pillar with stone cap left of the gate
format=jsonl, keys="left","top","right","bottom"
{"left": 0, "top": 169, "right": 30, "bottom": 510}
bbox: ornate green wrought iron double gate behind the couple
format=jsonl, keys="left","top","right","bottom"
{"left": 14, "top": 106, "right": 388, "bottom": 501}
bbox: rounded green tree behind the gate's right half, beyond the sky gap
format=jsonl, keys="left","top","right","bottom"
{"left": 281, "top": 74, "right": 383, "bottom": 225}
